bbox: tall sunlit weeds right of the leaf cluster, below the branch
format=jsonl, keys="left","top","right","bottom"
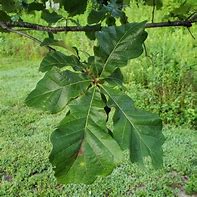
{"left": 124, "top": 28, "right": 197, "bottom": 129}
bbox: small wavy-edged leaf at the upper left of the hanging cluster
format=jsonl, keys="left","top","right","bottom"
{"left": 39, "top": 51, "right": 81, "bottom": 72}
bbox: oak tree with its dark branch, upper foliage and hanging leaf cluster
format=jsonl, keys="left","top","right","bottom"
{"left": 0, "top": 0, "right": 196, "bottom": 183}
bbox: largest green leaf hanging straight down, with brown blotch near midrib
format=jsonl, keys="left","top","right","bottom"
{"left": 50, "top": 87, "right": 122, "bottom": 184}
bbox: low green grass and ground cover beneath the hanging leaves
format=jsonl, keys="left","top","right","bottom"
{"left": 0, "top": 58, "right": 197, "bottom": 197}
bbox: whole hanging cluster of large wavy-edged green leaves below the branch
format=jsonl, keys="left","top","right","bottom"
{"left": 2, "top": 0, "right": 196, "bottom": 192}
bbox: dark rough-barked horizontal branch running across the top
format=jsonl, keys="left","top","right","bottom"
{"left": 0, "top": 19, "right": 197, "bottom": 33}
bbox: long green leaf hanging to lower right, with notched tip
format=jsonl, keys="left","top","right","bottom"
{"left": 102, "top": 85, "right": 164, "bottom": 168}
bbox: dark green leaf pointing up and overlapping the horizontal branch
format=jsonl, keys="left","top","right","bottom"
{"left": 94, "top": 22, "right": 147, "bottom": 77}
